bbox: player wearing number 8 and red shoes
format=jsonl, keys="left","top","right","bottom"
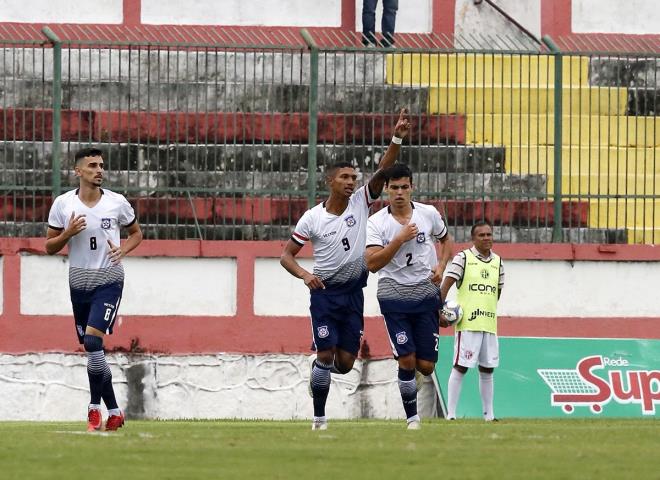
{"left": 46, "top": 148, "right": 142, "bottom": 431}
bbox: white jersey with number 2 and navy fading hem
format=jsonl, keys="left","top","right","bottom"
{"left": 367, "top": 202, "right": 448, "bottom": 311}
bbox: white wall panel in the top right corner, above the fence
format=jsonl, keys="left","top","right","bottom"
{"left": 571, "top": 0, "right": 660, "bottom": 35}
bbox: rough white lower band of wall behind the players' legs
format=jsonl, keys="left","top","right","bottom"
{"left": 0, "top": 353, "right": 440, "bottom": 420}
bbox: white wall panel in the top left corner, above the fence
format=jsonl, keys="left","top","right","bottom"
{"left": 0, "top": 0, "right": 124, "bottom": 23}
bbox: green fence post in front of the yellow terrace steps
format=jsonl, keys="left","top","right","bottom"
{"left": 543, "top": 35, "right": 564, "bottom": 242}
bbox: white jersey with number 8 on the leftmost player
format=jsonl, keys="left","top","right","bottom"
{"left": 48, "top": 189, "right": 136, "bottom": 290}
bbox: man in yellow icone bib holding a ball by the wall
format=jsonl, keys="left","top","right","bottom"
{"left": 440, "top": 220, "right": 504, "bottom": 421}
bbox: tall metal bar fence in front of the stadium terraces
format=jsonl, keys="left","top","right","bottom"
{"left": 0, "top": 29, "right": 660, "bottom": 243}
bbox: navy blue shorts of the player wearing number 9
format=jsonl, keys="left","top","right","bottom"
{"left": 309, "top": 289, "right": 364, "bottom": 356}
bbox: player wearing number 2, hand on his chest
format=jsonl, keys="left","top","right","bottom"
{"left": 366, "top": 163, "right": 453, "bottom": 430}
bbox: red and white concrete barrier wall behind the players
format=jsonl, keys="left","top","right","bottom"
{"left": 0, "top": 238, "right": 660, "bottom": 420}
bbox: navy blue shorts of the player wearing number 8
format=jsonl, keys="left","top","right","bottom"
{"left": 71, "top": 283, "right": 124, "bottom": 343}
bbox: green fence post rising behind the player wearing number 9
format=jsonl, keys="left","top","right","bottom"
{"left": 300, "top": 29, "right": 319, "bottom": 208}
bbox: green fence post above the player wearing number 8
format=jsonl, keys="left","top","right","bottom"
{"left": 41, "top": 27, "right": 62, "bottom": 198}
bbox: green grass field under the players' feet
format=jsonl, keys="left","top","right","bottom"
{"left": 0, "top": 419, "right": 660, "bottom": 480}
